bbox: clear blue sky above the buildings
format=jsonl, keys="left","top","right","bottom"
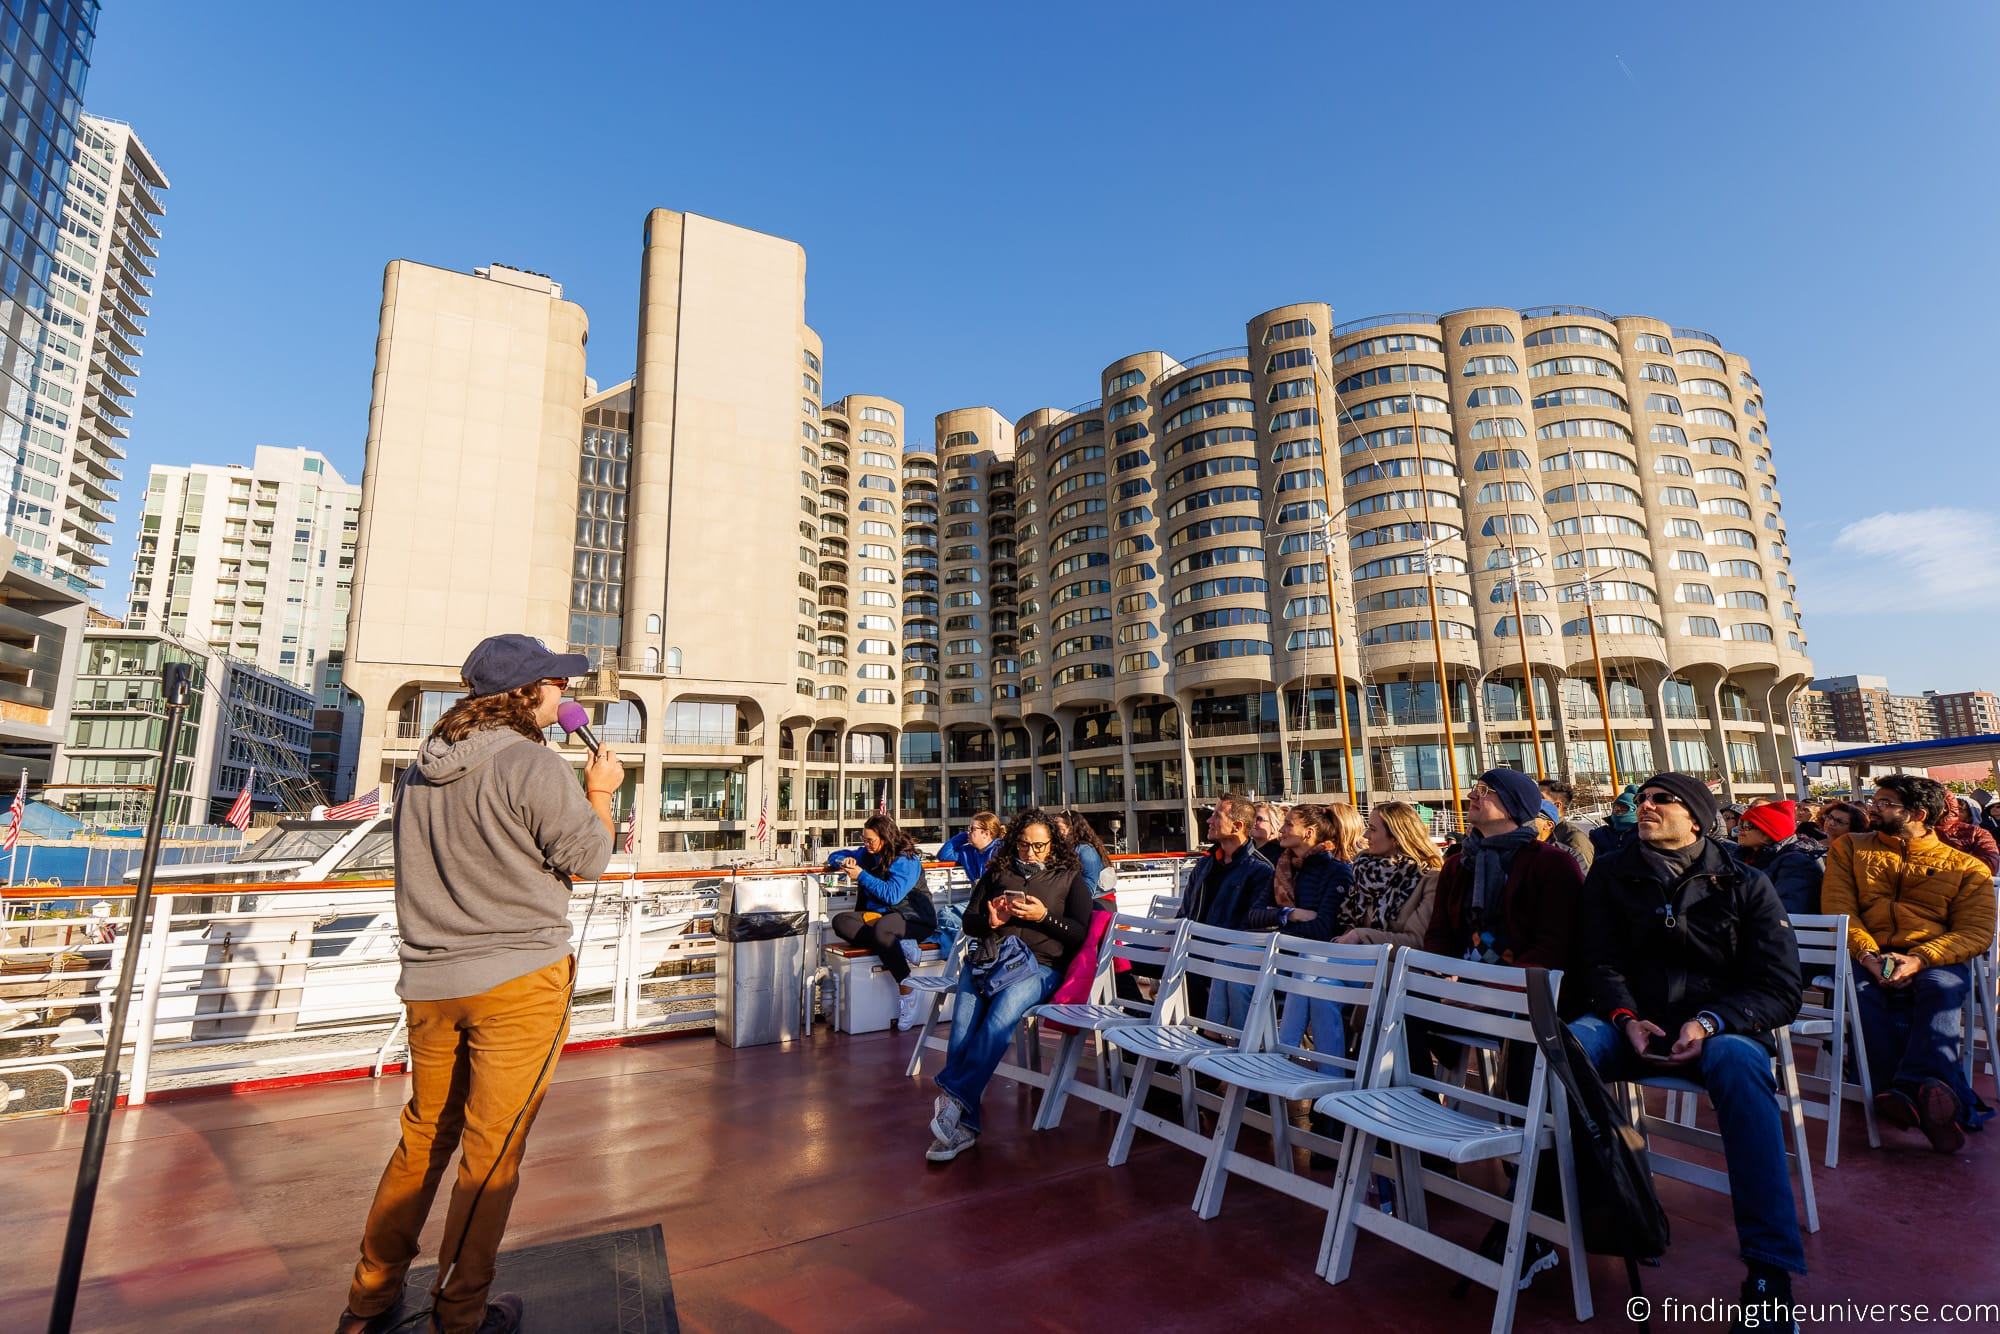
{"left": 86, "top": 10, "right": 2000, "bottom": 690}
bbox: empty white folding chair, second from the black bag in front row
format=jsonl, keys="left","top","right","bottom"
{"left": 1188, "top": 936, "right": 1390, "bottom": 1218}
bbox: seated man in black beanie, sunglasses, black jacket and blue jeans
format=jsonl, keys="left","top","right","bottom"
{"left": 1570, "top": 774, "right": 1806, "bottom": 1330}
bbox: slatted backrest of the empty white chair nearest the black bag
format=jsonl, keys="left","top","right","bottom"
{"left": 1368, "top": 950, "right": 1562, "bottom": 1118}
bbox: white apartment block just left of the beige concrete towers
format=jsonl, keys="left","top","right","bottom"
{"left": 126, "top": 444, "right": 362, "bottom": 688}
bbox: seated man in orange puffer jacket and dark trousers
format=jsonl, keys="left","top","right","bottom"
{"left": 1820, "top": 774, "right": 1994, "bottom": 1154}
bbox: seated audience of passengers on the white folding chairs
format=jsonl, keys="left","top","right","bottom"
{"left": 868, "top": 768, "right": 2000, "bottom": 1328}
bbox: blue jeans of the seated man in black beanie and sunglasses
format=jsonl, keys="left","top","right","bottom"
{"left": 1570, "top": 1014, "right": 1806, "bottom": 1274}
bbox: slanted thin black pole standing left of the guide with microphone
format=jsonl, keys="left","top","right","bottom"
{"left": 48, "top": 662, "right": 194, "bottom": 1334}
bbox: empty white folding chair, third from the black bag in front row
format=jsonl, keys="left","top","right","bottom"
{"left": 1104, "top": 922, "right": 1284, "bottom": 1168}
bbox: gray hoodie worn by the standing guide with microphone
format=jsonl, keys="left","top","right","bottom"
{"left": 396, "top": 728, "right": 612, "bottom": 1000}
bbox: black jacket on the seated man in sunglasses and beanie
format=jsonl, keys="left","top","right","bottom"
{"left": 1580, "top": 838, "right": 1800, "bottom": 1050}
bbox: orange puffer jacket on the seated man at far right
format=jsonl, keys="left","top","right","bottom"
{"left": 1820, "top": 832, "right": 1994, "bottom": 968}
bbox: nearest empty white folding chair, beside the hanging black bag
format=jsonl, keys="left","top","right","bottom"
{"left": 1314, "top": 950, "right": 1590, "bottom": 1334}
